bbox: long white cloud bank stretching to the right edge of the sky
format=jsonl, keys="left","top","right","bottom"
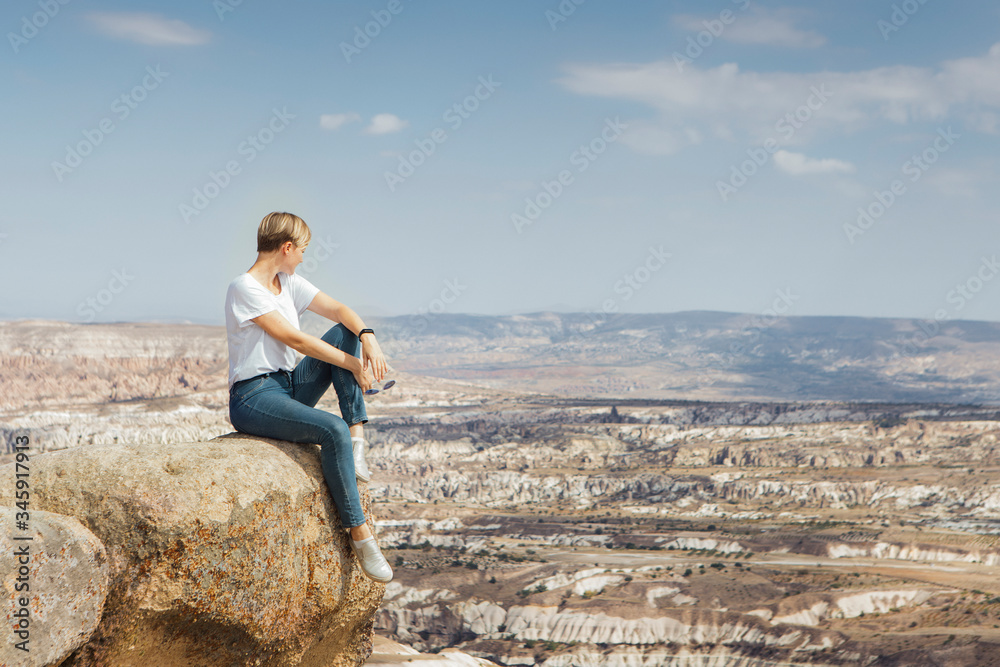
{"left": 558, "top": 44, "right": 1000, "bottom": 145}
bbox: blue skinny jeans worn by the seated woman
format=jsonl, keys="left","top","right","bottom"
{"left": 229, "top": 324, "right": 368, "bottom": 528}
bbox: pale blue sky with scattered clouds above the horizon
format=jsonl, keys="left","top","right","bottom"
{"left": 0, "top": 0, "right": 1000, "bottom": 324}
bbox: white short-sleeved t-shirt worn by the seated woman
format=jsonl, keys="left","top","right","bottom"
{"left": 226, "top": 273, "right": 319, "bottom": 387}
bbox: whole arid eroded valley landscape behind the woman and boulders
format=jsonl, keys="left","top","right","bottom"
{"left": 0, "top": 314, "right": 1000, "bottom": 667}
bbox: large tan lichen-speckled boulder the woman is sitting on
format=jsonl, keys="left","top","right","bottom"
{"left": 0, "top": 433, "right": 385, "bottom": 667}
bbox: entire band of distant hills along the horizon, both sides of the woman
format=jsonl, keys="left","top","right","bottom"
{"left": 7, "top": 311, "right": 1000, "bottom": 410}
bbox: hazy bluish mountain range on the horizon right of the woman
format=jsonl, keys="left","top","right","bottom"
{"left": 342, "top": 311, "right": 1000, "bottom": 405}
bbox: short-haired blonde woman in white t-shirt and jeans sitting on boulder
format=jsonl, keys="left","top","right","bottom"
{"left": 226, "top": 213, "right": 392, "bottom": 583}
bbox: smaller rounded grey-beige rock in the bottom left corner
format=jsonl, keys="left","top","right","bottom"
{"left": 0, "top": 508, "right": 108, "bottom": 667}
